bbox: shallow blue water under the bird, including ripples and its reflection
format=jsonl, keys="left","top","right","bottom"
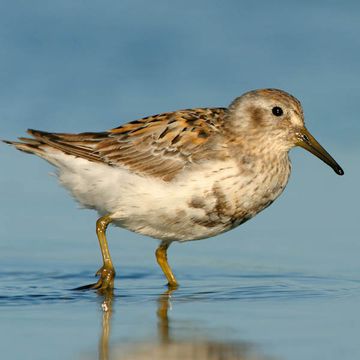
{"left": 0, "top": 264, "right": 360, "bottom": 359}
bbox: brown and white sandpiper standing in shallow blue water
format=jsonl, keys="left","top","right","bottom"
{"left": 4, "top": 88, "right": 344, "bottom": 291}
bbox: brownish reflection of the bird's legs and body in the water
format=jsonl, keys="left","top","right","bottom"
{"left": 95, "top": 290, "right": 269, "bottom": 360}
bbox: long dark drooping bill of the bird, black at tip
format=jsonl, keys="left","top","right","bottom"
{"left": 296, "top": 128, "right": 344, "bottom": 175}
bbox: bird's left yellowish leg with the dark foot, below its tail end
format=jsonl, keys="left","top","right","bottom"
{"left": 77, "top": 215, "right": 115, "bottom": 292}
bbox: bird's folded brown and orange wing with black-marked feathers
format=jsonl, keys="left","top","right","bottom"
{"left": 13, "top": 108, "right": 226, "bottom": 181}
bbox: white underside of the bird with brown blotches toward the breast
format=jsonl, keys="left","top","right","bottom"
{"left": 52, "top": 153, "right": 287, "bottom": 241}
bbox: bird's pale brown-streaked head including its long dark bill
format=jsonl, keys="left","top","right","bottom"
{"left": 229, "top": 89, "right": 344, "bottom": 175}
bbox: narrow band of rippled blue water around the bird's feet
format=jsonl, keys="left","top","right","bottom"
{"left": 0, "top": 269, "right": 360, "bottom": 306}
